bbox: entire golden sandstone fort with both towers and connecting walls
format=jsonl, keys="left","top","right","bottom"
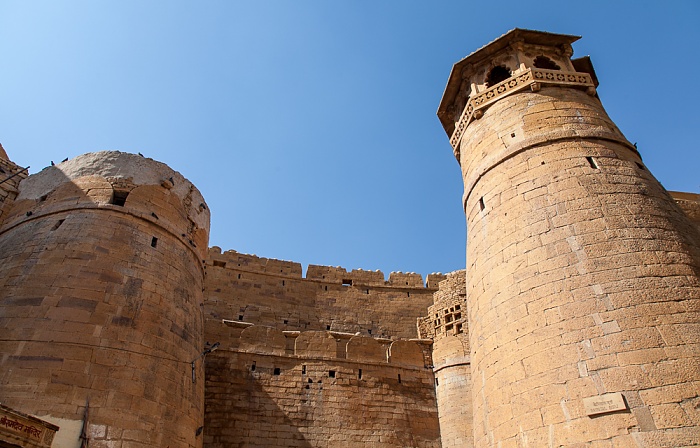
{"left": 0, "top": 29, "right": 700, "bottom": 448}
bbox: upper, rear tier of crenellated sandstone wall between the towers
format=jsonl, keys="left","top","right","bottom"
{"left": 204, "top": 247, "right": 445, "bottom": 341}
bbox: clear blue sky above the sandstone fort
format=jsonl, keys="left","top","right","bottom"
{"left": 0, "top": 0, "right": 700, "bottom": 275}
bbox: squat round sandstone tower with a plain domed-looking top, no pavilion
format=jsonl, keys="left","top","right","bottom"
{"left": 0, "top": 151, "right": 209, "bottom": 447}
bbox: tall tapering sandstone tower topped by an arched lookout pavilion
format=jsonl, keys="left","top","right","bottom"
{"left": 438, "top": 29, "right": 700, "bottom": 447}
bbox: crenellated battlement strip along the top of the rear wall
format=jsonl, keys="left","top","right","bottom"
{"left": 207, "top": 246, "right": 446, "bottom": 289}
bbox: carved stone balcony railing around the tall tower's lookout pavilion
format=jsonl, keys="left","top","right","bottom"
{"left": 450, "top": 68, "right": 596, "bottom": 160}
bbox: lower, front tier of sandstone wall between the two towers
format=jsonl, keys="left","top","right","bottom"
{"left": 204, "top": 322, "right": 440, "bottom": 448}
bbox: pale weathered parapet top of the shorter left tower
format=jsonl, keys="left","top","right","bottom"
{"left": 4, "top": 151, "right": 209, "bottom": 258}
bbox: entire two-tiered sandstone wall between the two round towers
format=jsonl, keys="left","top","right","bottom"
{"left": 204, "top": 248, "right": 445, "bottom": 447}
